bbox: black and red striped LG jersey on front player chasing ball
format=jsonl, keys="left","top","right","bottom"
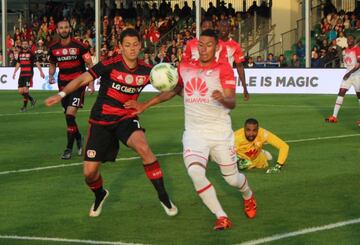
{"left": 88, "top": 55, "right": 151, "bottom": 125}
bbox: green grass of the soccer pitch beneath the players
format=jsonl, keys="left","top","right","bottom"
{"left": 0, "top": 91, "right": 360, "bottom": 244}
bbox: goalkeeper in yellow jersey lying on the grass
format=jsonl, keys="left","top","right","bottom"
{"left": 234, "top": 118, "right": 289, "bottom": 173}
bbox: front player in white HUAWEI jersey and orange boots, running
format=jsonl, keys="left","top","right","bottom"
{"left": 125, "top": 29, "right": 256, "bottom": 230}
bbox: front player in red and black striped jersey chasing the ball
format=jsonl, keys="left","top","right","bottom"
{"left": 45, "top": 28, "right": 178, "bottom": 217}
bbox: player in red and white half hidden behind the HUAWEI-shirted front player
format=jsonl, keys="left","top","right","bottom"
{"left": 218, "top": 20, "right": 250, "bottom": 101}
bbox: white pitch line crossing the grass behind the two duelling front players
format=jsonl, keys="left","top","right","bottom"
{"left": 0, "top": 134, "right": 360, "bottom": 175}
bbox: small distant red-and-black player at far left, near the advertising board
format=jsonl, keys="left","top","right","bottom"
{"left": 13, "top": 40, "right": 45, "bottom": 112}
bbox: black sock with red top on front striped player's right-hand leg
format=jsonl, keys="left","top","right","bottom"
{"left": 144, "top": 161, "right": 171, "bottom": 208}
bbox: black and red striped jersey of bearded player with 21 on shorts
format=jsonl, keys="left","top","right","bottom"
{"left": 49, "top": 38, "right": 90, "bottom": 90}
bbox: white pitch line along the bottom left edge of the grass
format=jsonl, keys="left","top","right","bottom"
{"left": 0, "top": 235, "right": 143, "bottom": 245}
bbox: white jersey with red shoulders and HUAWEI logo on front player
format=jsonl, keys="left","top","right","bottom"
{"left": 178, "top": 60, "right": 236, "bottom": 137}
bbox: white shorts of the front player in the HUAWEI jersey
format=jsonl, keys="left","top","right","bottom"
{"left": 183, "top": 131, "right": 236, "bottom": 168}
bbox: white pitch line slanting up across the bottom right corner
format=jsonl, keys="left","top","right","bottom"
{"left": 239, "top": 218, "right": 360, "bottom": 245}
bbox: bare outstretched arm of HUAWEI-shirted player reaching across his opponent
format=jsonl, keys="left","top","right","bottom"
{"left": 124, "top": 84, "right": 182, "bottom": 115}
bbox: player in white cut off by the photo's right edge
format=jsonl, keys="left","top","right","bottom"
{"left": 325, "top": 35, "right": 360, "bottom": 126}
